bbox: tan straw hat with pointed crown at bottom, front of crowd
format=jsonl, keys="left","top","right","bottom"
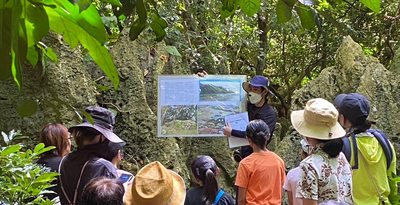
{"left": 124, "top": 161, "right": 186, "bottom": 205}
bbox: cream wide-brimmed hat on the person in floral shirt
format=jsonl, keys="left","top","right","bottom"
{"left": 290, "top": 98, "right": 346, "bottom": 140}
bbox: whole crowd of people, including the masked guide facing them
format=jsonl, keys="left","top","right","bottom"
{"left": 37, "top": 76, "right": 397, "bottom": 205}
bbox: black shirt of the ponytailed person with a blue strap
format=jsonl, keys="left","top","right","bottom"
{"left": 185, "top": 187, "right": 235, "bottom": 205}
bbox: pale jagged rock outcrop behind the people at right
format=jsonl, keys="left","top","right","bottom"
{"left": 277, "top": 36, "right": 400, "bottom": 171}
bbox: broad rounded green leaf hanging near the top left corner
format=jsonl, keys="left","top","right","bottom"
{"left": 25, "top": 3, "right": 49, "bottom": 47}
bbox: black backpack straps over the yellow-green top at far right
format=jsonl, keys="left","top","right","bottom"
{"left": 342, "top": 129, "right": 393, "bottom": 169}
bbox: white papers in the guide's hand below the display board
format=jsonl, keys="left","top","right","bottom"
{"left": 225, "top": 112, "right": 249, "bottom": 148}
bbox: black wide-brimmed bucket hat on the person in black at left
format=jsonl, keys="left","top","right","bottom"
{"left": 68, "top": 106, "right": 125, "bottom": 143}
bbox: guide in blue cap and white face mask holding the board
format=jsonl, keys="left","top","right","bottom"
{"left": 223, "top": 75, "right": 276, "bottom": 162}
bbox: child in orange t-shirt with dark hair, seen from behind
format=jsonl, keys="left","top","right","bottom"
{"left": 235, "top": 120, "right": 286, "bottom": 205}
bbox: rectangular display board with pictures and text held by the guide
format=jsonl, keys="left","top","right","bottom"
{"left": 157, "top": 75, "right": 246, "bottom": 137}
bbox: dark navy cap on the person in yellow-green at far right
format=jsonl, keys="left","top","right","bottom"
{"left": 333, "top": 93, "right": 370, "bottom": 125}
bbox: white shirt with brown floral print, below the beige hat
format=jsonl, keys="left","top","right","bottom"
{"left": 296, "top": 148, "right": 353, "bottom": 204}
